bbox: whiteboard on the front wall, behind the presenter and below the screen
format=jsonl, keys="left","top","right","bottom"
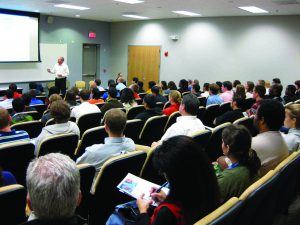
{"left": 0, "top": 43, "right": 67, "bottom": 84}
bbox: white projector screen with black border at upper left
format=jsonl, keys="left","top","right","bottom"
{"left": 0, "top": 9, "right": 40, "bottom": 62}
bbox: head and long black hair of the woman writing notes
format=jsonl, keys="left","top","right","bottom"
{"left": 153, "top": 135, "right": 220, "bottom": 224}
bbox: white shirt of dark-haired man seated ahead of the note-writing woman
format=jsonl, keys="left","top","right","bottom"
{"left": 161, "top": 116, "right": 205, "bottom": 141}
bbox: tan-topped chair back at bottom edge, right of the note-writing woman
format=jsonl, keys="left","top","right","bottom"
{"left": 194, "top": 197, "right": 243, "bottom": 225}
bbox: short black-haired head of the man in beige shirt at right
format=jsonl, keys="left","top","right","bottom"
{"left": 254, "top": 99, "right": 285, "bottom": 133}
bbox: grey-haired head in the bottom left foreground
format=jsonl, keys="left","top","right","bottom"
{"left": 26, "top": 153, "right": 81, "bottom": 220}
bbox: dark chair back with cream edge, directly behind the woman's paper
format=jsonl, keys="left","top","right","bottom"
{"left": 89, "top": 151, "right": 147, "bottom": 225}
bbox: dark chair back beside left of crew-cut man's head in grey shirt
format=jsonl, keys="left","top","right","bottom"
{"left": 74, "top": 126, "right": 108, "bottom": 158}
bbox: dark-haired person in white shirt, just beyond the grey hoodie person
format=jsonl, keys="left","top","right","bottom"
{"left": 71, "top": 89, "right": 101, "bottom": 120}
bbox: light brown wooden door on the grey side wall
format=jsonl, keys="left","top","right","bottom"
{"left": 127, "top": 45, "right": 160, "bottom": 91}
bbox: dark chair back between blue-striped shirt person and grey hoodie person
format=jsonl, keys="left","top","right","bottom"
{"left": 10, "top": 120, "right": 43, "bottom": 138}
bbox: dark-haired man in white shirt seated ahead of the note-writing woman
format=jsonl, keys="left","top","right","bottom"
{"left": 151, "top": 94, "right": 205, "bottom": 147}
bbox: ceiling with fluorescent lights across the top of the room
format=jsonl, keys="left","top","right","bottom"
{"left": 0, "top": 0, "right": 300, "bottom": 22}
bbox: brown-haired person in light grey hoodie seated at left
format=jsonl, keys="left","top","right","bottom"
{"left": 34, "top": 100, "right": 80, "bottom": 155}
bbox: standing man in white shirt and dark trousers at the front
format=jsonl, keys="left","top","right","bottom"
{"left": 47, "top": 56, "right": 69, "bottom": 95}
